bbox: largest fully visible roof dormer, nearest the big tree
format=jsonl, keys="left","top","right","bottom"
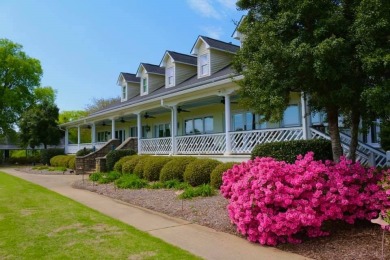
{"left": 191, "top": 36, "right": 240, "bottom": 78}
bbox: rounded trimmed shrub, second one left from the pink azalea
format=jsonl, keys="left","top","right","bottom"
{"left": 184, "top": 159, "right": 221, "bottom": 187}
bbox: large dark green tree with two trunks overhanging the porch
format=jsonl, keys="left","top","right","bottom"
{"left": 234, "top": 0, "right": 389, "bottom": 161}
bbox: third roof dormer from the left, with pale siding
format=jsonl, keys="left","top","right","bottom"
{"left": 160, "top": 51, "right": 197, "bottom": 88}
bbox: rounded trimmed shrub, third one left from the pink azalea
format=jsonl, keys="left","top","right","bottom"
{"left": 160, "top": 156, "right": 196, "bottom": 182}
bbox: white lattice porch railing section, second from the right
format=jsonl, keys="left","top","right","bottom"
{"left": 176, "top": 133, "right": 226, "bottom": 154}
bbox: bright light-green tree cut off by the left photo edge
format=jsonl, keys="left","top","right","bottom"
{"left": 0, "top": 39, "right": 42, "bottom": 135}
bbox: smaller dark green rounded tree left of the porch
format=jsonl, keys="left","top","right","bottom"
{"left": 19, "top": 100, "right": 62, "bottom": 149}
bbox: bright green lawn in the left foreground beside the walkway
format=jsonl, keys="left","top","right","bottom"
{"left": 0, "top": 172, "right": 198, "bottom": 259}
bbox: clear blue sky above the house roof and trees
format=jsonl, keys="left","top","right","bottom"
{"left": 0, "top": 0, "right": 243, "bottom": 111}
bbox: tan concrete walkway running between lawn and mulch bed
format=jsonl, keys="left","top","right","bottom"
{"left": 0, "top": 168, "right": 308, "bottom": 260}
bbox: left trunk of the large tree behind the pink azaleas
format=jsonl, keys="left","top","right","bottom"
{"left": 326, "top": 107, "right": 343, "bottom": 162}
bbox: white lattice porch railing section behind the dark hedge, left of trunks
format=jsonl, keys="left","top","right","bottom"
{"left": 230, "top": 127, "right": 303, "bottom": 154}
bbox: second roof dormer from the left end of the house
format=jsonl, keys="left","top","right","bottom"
{"left": 136, "top": 63, "right": 165, "bottom": 96}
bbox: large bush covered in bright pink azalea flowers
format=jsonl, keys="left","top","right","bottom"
{"left": 221, "top": 152, "right": 390, "bottom": 246}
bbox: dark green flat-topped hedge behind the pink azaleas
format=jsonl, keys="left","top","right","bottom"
{"left": 251, "top": 139, "right": 333, "bottom": 163}
